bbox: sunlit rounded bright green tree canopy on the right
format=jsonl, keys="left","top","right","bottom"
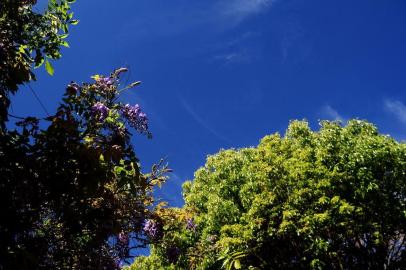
{"left": 131, "top": 120, "right": 406, "bottom": 269}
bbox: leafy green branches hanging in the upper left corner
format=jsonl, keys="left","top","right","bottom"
{"left": 0, "top": 0, "right": 77, "bottom": 130}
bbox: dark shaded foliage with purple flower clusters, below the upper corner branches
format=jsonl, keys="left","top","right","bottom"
{"left": 0, "top": 69, "right": 166, "bottom": 269}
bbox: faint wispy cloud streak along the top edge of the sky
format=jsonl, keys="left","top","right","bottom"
{"left": 117, "top": 0, "right": 275, "bottom": 40}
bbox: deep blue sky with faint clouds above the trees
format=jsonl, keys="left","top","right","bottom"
{"left": 12, "top": 0, "right": 406, "bottom": 206}
